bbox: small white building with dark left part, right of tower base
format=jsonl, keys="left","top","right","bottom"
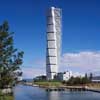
{"left": 56, "top": 71, "right": 72, "bottom": 81}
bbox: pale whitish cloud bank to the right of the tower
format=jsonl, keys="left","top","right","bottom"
{"left": 61, "top": 51, "right": 100, "bottom": 71}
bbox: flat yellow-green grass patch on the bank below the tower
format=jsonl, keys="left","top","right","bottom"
{"left": 34, "top": 81, "right": 63, "bottom": 87}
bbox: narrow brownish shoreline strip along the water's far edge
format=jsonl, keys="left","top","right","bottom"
{"left": 22, "top": 82, "right": 100, "bottom": 93}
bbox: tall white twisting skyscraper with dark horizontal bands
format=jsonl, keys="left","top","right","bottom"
{"left": 46, "top": 7, "right": 62, "bottom": 80}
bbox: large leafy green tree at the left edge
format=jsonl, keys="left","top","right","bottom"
{"left": 0, "top": 21, "right": 24, "bottom": 88}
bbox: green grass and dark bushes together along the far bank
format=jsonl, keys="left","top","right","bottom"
{"left": 34, "top": 74, "right": 92, "bottom": 87}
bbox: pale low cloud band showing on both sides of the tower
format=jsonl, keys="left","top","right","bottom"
{"left": 22, "top": 51, "right": 100, "bottom": 78}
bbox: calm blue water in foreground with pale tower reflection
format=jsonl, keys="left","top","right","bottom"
{"left": 14, "top": 85, "right": 100, "bottom": 100}
